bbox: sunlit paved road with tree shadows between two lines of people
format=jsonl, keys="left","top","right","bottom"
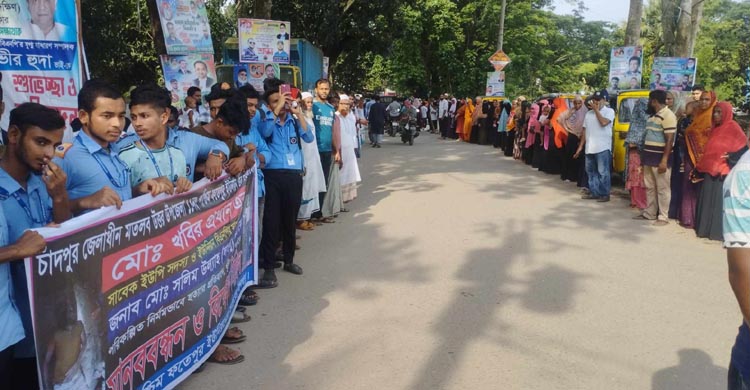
{"left": 182, "top": 135, "right": 740, "bottom": 390}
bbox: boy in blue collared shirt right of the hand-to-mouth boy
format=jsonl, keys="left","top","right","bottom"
{"left": 55, "top": 79, "right": 174, "bottom": 214}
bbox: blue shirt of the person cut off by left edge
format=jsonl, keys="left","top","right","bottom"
{"left": 0, "top": 207, "right": 24, "bottom": 351}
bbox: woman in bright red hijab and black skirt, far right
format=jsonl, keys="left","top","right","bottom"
{"left": 694, "top": 102, "right": 747, "bottom": 240}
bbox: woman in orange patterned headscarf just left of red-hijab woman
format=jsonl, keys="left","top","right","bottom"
{"left": 678, "top": 91, "right": 716, "bottom": 227}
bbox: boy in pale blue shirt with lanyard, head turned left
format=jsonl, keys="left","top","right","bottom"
{"left": 120, "top": 84, "right": 193, "bottom": 195}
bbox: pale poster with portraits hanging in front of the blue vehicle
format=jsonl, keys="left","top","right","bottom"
{"left": 239, "top": 19, "right": 292, "bottom": 64}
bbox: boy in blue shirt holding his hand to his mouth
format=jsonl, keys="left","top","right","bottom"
{"left": 0, "top": 103, "right": 71, "bottom": 388}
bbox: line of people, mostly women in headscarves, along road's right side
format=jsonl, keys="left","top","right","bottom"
{"left": 428, "top": 85, "right": 747, "bottom": 235}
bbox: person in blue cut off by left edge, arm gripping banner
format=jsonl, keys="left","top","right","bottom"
{"left": 0, "top": 207, "right": 47, "bottom": 389}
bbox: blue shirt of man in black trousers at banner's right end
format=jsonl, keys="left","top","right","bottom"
{"left": 261, "top": 110, "right": 315, "bottom": 171}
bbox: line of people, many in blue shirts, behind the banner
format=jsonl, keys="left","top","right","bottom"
{"left": 0, "top": 79, "right": 367, "bottom": 388}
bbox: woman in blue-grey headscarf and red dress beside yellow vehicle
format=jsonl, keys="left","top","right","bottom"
{"left": 624, "top": 99, "right": 648, "bottom": 210}
